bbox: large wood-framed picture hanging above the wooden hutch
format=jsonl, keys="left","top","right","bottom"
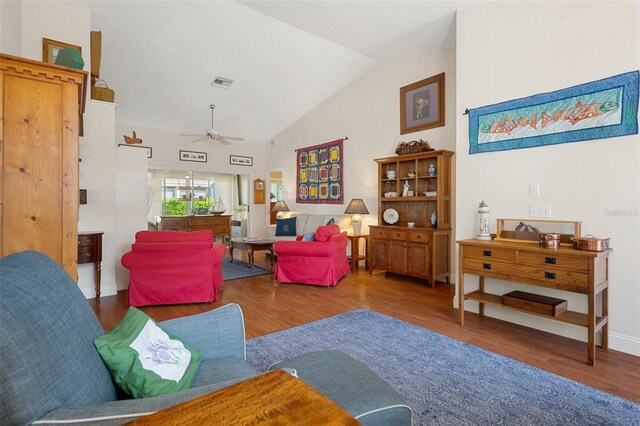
{"left": 400, "top": 73, "right": 444, "bottom": 135}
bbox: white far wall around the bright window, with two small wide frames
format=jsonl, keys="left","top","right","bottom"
{"left": 115, "top": 123, "right": 268, "bottom": 237}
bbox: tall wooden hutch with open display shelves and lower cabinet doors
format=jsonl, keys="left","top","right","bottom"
{"left": 369, "top": 150, "right": 453, "bottom": 287}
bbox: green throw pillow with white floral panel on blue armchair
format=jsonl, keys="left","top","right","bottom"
{"left": 93, "top": 307, "right": 202, "bottom": 398}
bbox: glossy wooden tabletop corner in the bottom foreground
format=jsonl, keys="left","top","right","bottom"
{"left": 122, "top": 370, "right": 360, "bottom": 426}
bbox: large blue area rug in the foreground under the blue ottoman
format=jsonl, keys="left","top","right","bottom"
{"left": 247, "top": 309, "right": 640, "bottom": 426}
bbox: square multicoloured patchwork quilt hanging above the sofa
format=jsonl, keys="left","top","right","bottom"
{"left": 296, "top": 139, "right": 344, "bottom": 204}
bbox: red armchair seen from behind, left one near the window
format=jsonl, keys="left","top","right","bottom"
{"left": 121, "top": 230, "right": 227, "bottom": 306}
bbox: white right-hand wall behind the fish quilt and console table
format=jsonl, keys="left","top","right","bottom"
{"left": 455, "top": 1, "right": 640, "bottom": 355}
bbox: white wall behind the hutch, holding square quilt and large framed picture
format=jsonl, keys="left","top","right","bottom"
{"left": 267, "top": 51, "right": 456, "bottom": 240}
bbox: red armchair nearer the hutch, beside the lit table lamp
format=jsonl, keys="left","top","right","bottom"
{"left": 273, "top": 225, "right": 351, "bottom": 287}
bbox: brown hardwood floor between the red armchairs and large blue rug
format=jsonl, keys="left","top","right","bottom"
{"left": 90, "top": 252, "right": 640, "bottom": 403}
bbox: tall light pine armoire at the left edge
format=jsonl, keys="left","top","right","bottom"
{"left": 0, "top": 54, "right": 87, "bottom": 279}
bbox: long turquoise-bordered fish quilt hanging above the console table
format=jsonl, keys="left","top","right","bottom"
{"left": 469, "top": 71, "right": 638, "bottom": 154}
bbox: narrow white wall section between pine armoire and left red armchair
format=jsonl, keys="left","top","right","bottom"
{"left": 78, "top": 100, "right": 120, "bottom": 298}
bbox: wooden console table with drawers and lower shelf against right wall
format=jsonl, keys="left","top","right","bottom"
{"left": 458, "top": 240, "right": 611, "bottom": 365}
